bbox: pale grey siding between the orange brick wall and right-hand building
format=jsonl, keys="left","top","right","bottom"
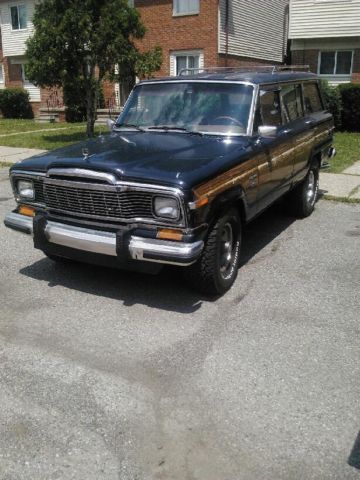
{"left": 219, "top": 0, "right": 288, "bottom": 62}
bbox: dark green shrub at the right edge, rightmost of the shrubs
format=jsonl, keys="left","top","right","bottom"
{"left": 339, "top": 83, "right": 360, "bottom": 132}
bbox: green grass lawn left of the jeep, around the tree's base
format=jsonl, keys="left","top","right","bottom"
{"left": 0, "top": 119, "right": 108, "bottom": 150}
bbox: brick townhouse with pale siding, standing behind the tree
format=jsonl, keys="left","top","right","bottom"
{"left": 0, "top": 0, "right": 288, "bottom": 117}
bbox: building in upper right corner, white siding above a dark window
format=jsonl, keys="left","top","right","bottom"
{"left": 289, "top": 0, "right": 360, "bottom": 84}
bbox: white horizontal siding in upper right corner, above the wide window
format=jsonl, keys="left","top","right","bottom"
{"left": 289, "top": 0, "right": 360, "bottom": 39}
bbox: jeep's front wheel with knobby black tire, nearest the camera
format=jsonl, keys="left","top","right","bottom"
{"left": 184, "top": 209, "right": 242, "bottom": 295}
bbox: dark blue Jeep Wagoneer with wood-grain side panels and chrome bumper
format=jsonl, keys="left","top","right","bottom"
{"left": 5, "top": 67, "right": 334, "bottom": 295}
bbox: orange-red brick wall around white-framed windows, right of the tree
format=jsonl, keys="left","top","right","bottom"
{"left": 135, "top": 0, "right": 218, "bottom": 76}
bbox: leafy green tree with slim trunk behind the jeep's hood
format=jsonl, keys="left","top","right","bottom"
{"left": 26, "top": 0, "right": 162, "bottom": 137}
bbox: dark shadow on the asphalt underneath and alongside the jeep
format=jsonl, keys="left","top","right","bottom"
{"left": 20, "top": 206, "right": 294, "bottom": 314}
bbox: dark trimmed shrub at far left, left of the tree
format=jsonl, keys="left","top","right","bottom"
{"left": 0, "top": 88, "right": 34, "bottom": 118}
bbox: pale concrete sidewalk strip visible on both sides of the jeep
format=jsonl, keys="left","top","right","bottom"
{"left": 0, "top": 146, "right": 360, "bottom": 200}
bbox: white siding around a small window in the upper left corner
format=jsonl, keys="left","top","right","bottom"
{"left": 0, "top": 0, "right": 35, "bottom": 57}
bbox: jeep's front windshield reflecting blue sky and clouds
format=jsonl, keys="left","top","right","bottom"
{"left": 116, "top": 81, "right": 253, "bottom": 135}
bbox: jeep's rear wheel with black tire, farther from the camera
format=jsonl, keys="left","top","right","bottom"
{"left": 285, "top": 164, "right": 319, "bottom": 218}
